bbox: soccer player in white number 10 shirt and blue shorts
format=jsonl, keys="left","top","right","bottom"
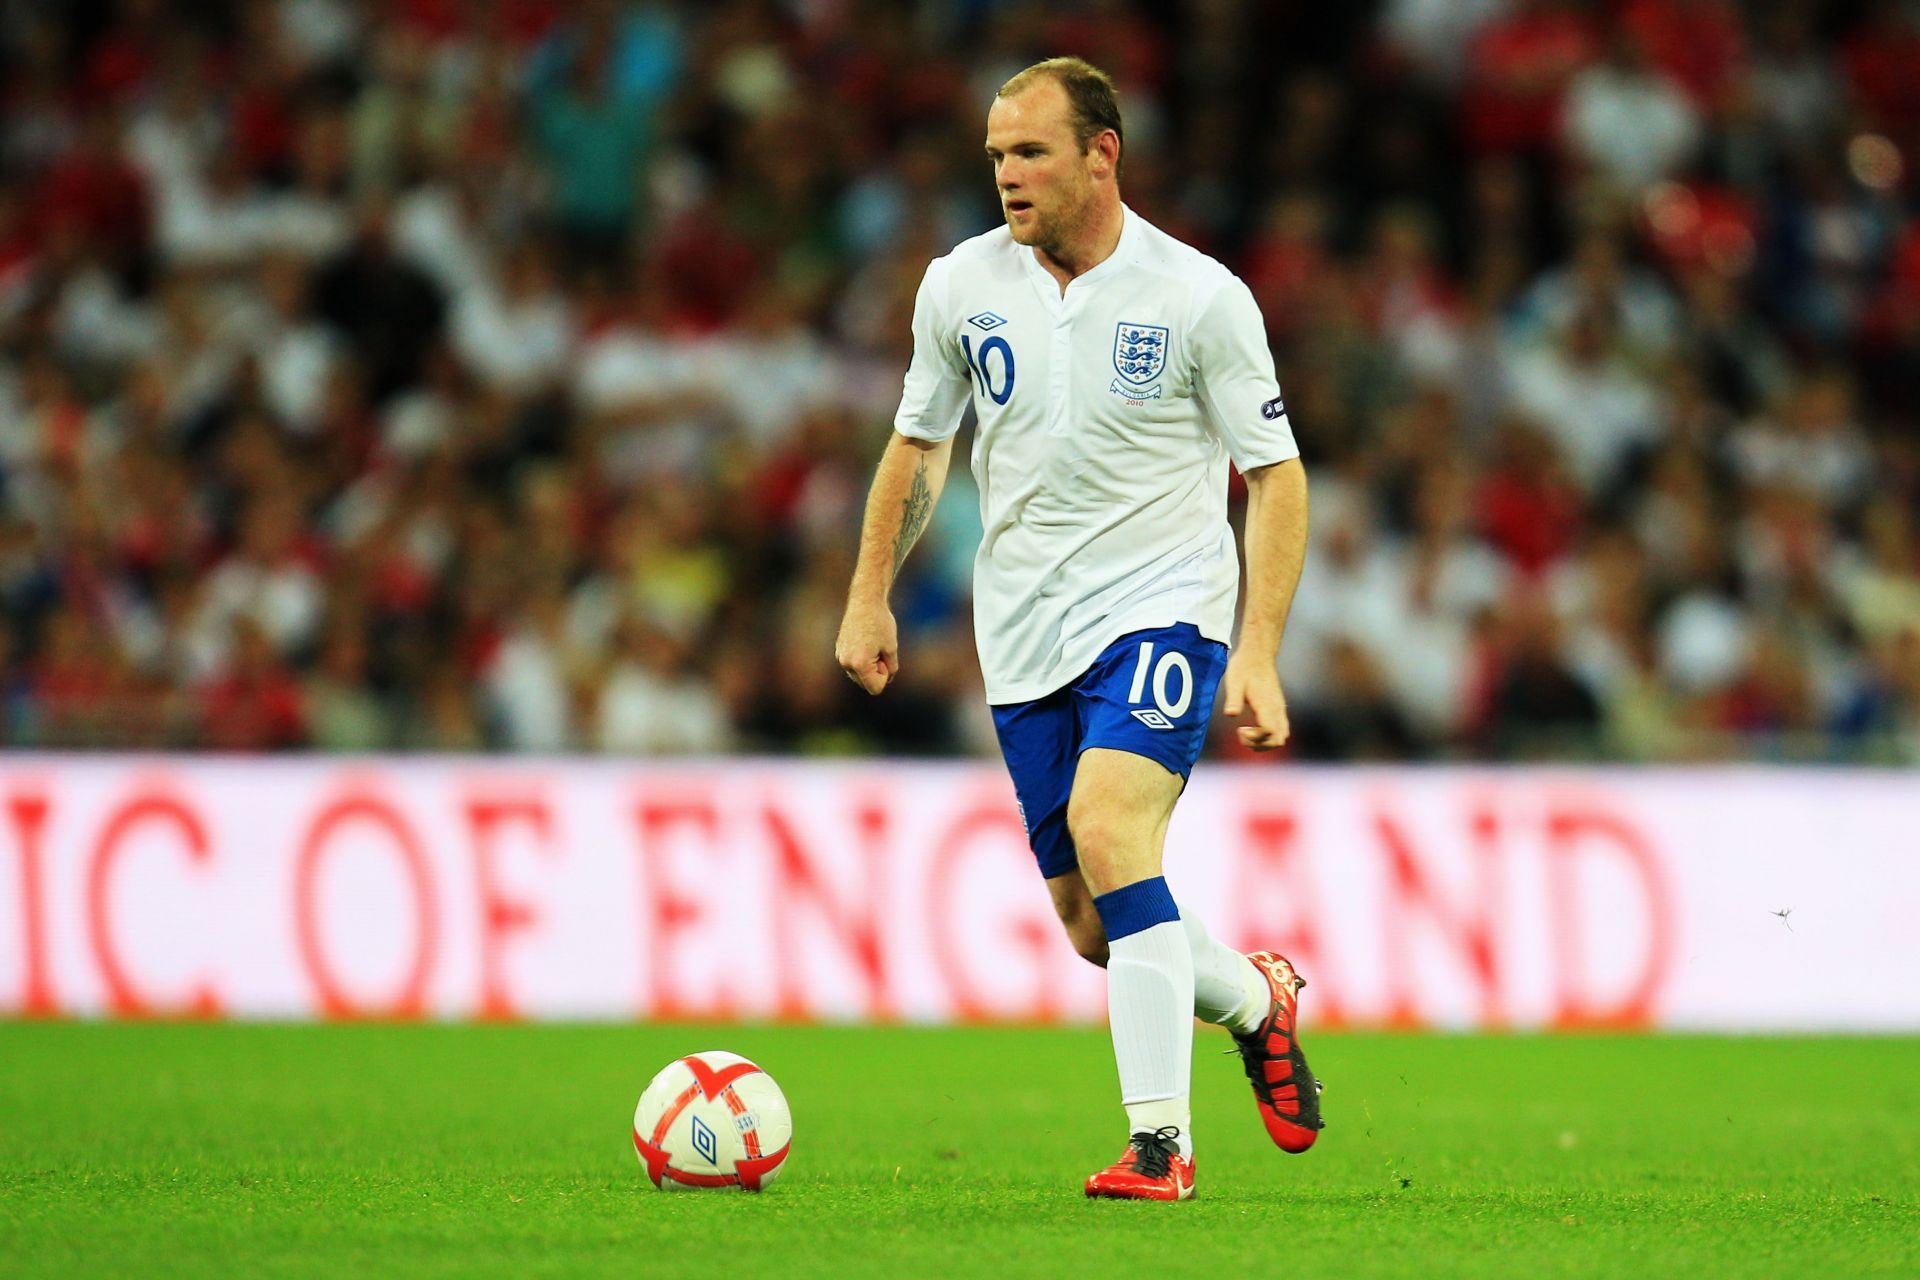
{"left": 835, "top": 58, "right": 1321, "bottom": 1199}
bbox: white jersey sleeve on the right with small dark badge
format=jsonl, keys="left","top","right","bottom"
{"left": 1188, "top": 278, "right": 1300, "bottom": 472}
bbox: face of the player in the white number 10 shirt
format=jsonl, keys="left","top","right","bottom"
{"left": 987, "top": 81, "right": 1096, "bottom": 249}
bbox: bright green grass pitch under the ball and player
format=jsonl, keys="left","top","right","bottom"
{"left": 0, "top": 1023, "right": 1920, "bottom": 1280}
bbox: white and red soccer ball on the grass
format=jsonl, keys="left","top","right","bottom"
{"left": 634, "top": 1050, "right": 793, "bottom": 1192}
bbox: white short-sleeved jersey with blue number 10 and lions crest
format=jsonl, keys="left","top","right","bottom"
{"left": 893, "top": 209, "right": 1300, "bottom": 704}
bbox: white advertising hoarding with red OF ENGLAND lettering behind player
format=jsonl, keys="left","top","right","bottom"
{"left": 0, "top": 756, "right": 1920, "bottom": 1031}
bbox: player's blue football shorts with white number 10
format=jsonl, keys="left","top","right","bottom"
{"left": 993, "top": 622, "right": 1227, "bottom": 879}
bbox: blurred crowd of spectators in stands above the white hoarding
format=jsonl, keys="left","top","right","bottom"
{"left": 0, "top": 0, "right": 1920, "bottom": 764}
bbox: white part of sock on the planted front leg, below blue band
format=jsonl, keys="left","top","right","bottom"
{"left": 1106, "top": 919, "right": 1194, "bottom": 1157}
